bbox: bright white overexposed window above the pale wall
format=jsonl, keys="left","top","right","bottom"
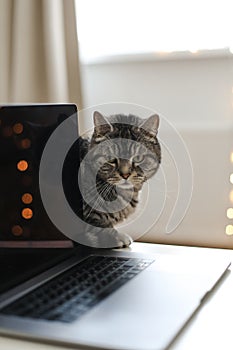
{"left": 76, "top": 0, "right": 233, "bottom": 62}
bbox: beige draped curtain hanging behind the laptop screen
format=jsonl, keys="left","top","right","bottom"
{"left": 0, "top": 0, "right": 82, "bottom": 109}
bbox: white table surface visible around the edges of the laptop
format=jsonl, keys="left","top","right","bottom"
{"left": 0, "top": 243, "right": 233, "bottom": 350}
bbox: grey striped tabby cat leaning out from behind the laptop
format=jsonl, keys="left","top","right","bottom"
{"left": 79, "top": 111, "right": 161, "bottom": 248}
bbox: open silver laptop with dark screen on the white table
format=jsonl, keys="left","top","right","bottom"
{"left": 0, "top": 104, "right": 230, "bottom": 350}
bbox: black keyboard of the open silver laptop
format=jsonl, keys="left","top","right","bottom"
{"left": 0, "top": 256, "right": 153, "bottom": 322}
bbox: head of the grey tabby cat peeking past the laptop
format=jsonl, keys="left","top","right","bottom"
{"left": 90, "top": 112, "right": 161, "bottom": 190}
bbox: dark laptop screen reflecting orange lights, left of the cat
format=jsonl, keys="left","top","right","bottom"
{"left": 0, "top": 104, "right": 81, "bottom": 247}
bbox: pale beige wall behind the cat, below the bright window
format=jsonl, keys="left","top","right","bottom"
{"left": 78, "top": 57, "right": 233, "bottom": 247}
